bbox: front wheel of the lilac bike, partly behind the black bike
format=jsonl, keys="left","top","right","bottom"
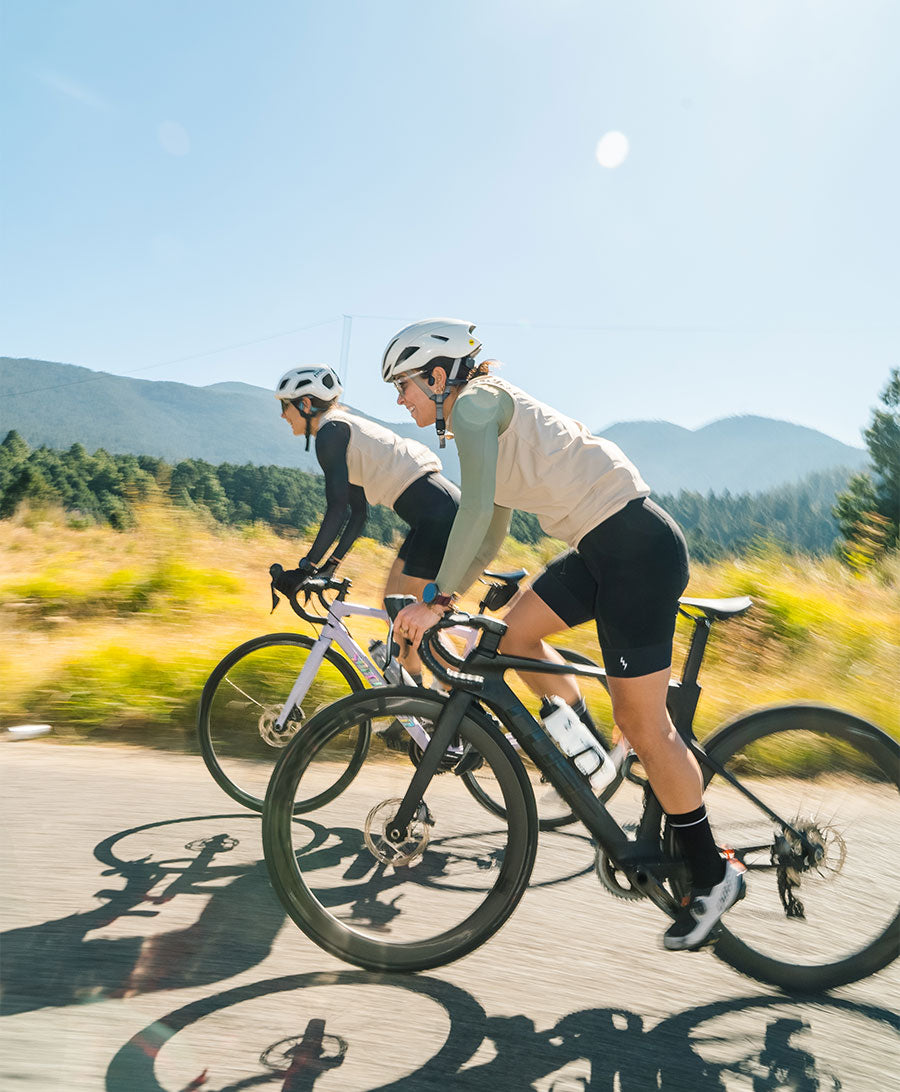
{"left": 197, "top": 633, "right": 368, "bottom": 811}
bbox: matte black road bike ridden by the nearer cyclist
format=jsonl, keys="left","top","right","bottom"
{"left": 263, "top": 597, "right": 900, "bottom": 992}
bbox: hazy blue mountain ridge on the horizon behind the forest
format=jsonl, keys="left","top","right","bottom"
{"left": 0, "top": 357, "right": 867, "bottom": 495}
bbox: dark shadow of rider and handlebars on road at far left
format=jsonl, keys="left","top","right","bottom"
{"left": 0, "top": 816, "right": 284, "bottom": 1016}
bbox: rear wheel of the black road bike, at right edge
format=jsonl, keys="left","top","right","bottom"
{"left": 707, "top": 711, "right": 900, "bottom": 987}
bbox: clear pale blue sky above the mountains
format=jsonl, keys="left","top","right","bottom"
{"left": 0, "top": 0, "right": 900, "bottom": 444}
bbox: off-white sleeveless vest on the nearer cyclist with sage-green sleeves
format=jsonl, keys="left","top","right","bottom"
{"left": 466, "top": 376, "right": 650, "bottom": 546}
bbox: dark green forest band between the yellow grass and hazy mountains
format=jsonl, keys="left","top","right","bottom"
{"left": 0, "top": 432, "right": 846, "bottom": 561}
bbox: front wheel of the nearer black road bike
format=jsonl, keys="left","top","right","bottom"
{"left": 262, "top": 687, "right": 537, "bottom": 971}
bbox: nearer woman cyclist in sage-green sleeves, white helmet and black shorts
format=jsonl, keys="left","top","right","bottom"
{"left": 382, "top": 319, "right": 744, "bottom": 950}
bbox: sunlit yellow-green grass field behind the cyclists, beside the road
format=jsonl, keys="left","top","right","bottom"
{"left": 0, "top": 505, "right": 900, "bottom": 746}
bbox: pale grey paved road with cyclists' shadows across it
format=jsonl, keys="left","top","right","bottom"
{"left": 0, "top": 740, "right": 900, "bottom": 1092}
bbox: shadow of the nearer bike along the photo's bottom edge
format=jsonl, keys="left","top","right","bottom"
{"left": 106, "top": 971, "right": 898, "bottom": 1092}
